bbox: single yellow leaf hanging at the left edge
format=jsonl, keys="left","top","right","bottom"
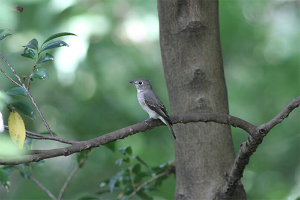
{"left": 8, "top": 111, "right": 26, "bottom": 149}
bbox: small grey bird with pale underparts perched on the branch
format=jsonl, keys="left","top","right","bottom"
{"left": 129, "top": 78, "right": 176, "bottom": 139}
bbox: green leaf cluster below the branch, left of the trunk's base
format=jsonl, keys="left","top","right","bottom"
{"left": 80, "top": 146, "right": 172, "bottom": 200}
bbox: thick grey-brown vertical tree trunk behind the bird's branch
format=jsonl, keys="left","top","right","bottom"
{"left": 158, "top": 0, "right": 246, "bottom": 199}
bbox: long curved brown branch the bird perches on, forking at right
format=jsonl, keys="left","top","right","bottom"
{"left": 0, "top": 97, "right": 300, "bottom": 167}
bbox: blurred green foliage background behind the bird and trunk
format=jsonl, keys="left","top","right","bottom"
{"left": 0, "top": 0, "right": 300, "bottom": 199}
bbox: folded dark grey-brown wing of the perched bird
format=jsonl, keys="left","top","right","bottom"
{"left": 145, "top": 92, "right": 173, "bottom": 125}
